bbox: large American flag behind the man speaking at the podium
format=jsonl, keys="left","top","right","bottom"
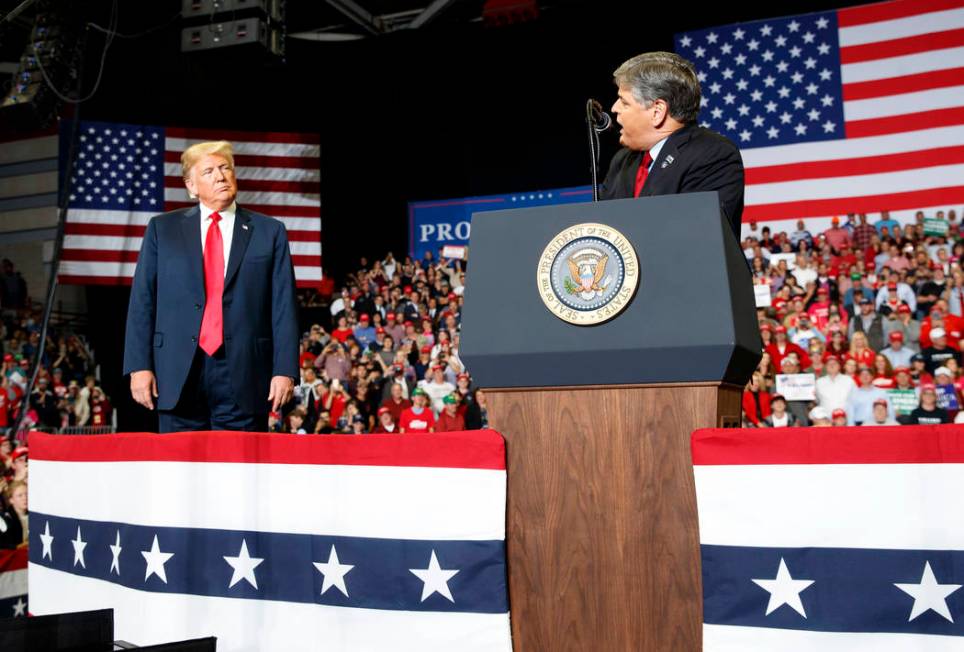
{"left": 675, "top": 0, "right": 964, "bottom": 227}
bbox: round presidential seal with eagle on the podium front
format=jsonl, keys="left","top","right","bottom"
{"left": 536, "top": 222, "right": 639, "bottom": 326}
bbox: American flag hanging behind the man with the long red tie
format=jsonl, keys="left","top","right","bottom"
{"left": 59, "top": 122, "right": 321, "bottom": 287}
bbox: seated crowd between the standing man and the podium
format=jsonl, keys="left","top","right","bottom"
{"left": 280, "top": 253, "right": 488, "bottom": 434}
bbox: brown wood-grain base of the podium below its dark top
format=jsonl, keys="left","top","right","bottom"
{"left": 487, "top": 383, "right": 742, "bottom": 652}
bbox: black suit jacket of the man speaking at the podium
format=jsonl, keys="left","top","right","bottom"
{"left": 599, "top": 125, "right": 743, "bottom": 240}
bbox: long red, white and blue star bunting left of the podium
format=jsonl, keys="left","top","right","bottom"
{"left": 28, "top": 430, "right": 512, "bottom": 652}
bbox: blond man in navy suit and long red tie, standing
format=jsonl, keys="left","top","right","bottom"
{"left": 124, "top": 141, "right": 298, "bottom": 432}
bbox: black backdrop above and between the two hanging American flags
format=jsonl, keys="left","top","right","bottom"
{"left": 64, "top": 0, "right": 858, "bottom": 430}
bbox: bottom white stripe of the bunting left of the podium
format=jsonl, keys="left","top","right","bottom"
{"left": 30, "top": 564, "right": 512, "bottom": 652}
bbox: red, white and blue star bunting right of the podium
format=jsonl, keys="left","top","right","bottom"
{"left": 691, "top": 425, "right": 964, "bottom": 652}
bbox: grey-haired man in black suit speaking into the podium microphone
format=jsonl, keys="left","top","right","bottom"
{"left": 600, "top": 52, "right": 743, "bottom": 239}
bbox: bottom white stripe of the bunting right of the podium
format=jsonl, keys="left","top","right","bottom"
{"left": 703, "top": 624, "right": 961, "bottom": 652}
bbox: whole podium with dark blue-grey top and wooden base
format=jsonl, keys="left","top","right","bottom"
{"left": 460, "top": 192, "right": 761, "bottom": 652}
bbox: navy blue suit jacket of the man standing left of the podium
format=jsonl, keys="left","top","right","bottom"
{"left": 124, "top": 206, "right": 298, "bottom": 415}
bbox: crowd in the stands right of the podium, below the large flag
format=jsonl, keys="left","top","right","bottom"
{"left": 743, "top": 210, "right": 964, "bottom": 427}
